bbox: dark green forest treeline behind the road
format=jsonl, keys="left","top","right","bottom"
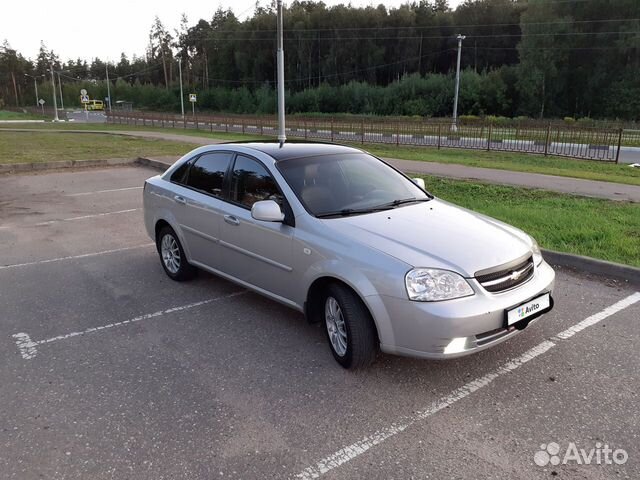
{"left": 0, "top": 0, "right": 640, "bottom": 120}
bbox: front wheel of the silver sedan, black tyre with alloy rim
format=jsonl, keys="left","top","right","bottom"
{"left": 321, "top": 284, "right": 378, "bottom": 370}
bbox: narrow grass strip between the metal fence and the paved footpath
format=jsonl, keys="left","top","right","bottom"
{"left": 5, "top": 123, "right": 640, "bottom": 185}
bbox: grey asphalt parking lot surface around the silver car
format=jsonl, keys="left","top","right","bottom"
{"left": 0, "top": 167, "right": 640, "bottom": 480}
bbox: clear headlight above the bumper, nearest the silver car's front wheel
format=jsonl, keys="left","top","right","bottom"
{"left": 404, "top": 268, "right": 473, "bottom": 302}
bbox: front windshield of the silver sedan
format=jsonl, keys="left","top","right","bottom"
{"left": 277, "top": 153, "right": 431, "bottom": 218}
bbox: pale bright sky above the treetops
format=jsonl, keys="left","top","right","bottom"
{"left": 0, "top": 0, "right": 462, "bottom": 62}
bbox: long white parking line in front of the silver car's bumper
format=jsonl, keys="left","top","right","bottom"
{"left": 295, "top": 292, "right": 640, "bottom": 480}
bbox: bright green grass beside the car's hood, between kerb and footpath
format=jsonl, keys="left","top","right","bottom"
{"left": 423, "top": 177, "right": 640, "bottom": 267}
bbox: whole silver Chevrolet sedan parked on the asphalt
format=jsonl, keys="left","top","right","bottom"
{"left": 143, "top": 142, "right": 555, "bottom": 368}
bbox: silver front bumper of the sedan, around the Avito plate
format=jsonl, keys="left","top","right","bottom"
{"left": 367, "top": 261, "right": 555, "bottom": 359}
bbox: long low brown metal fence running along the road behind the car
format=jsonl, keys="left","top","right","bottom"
{"left": 107, "top": 112, "right": 640, "bottom": 163}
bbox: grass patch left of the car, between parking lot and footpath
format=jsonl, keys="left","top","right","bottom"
{"left": 0, "top": 131, "right": 195, "bottom": 163}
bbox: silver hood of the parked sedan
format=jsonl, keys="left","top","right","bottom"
{"left": 324, "top": 199, "right": 532, "bottom": 277}
